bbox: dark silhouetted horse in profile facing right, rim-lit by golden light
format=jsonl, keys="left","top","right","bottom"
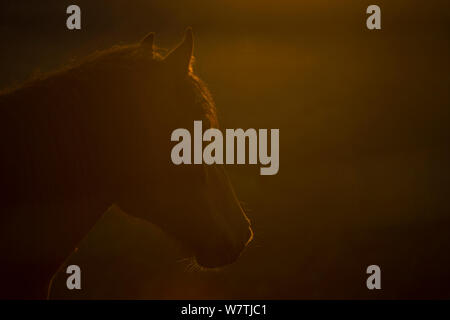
{"left": 0, "top": 28, "right": 253, "bottom": 299}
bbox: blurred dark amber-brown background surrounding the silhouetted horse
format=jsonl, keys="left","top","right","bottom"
{"left": 0, "top": 0, "right": 450, "bottom": 299}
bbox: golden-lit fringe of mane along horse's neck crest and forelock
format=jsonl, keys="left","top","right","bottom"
{"left": 0, "top": 43, "right": 218, "bottom": 127}
